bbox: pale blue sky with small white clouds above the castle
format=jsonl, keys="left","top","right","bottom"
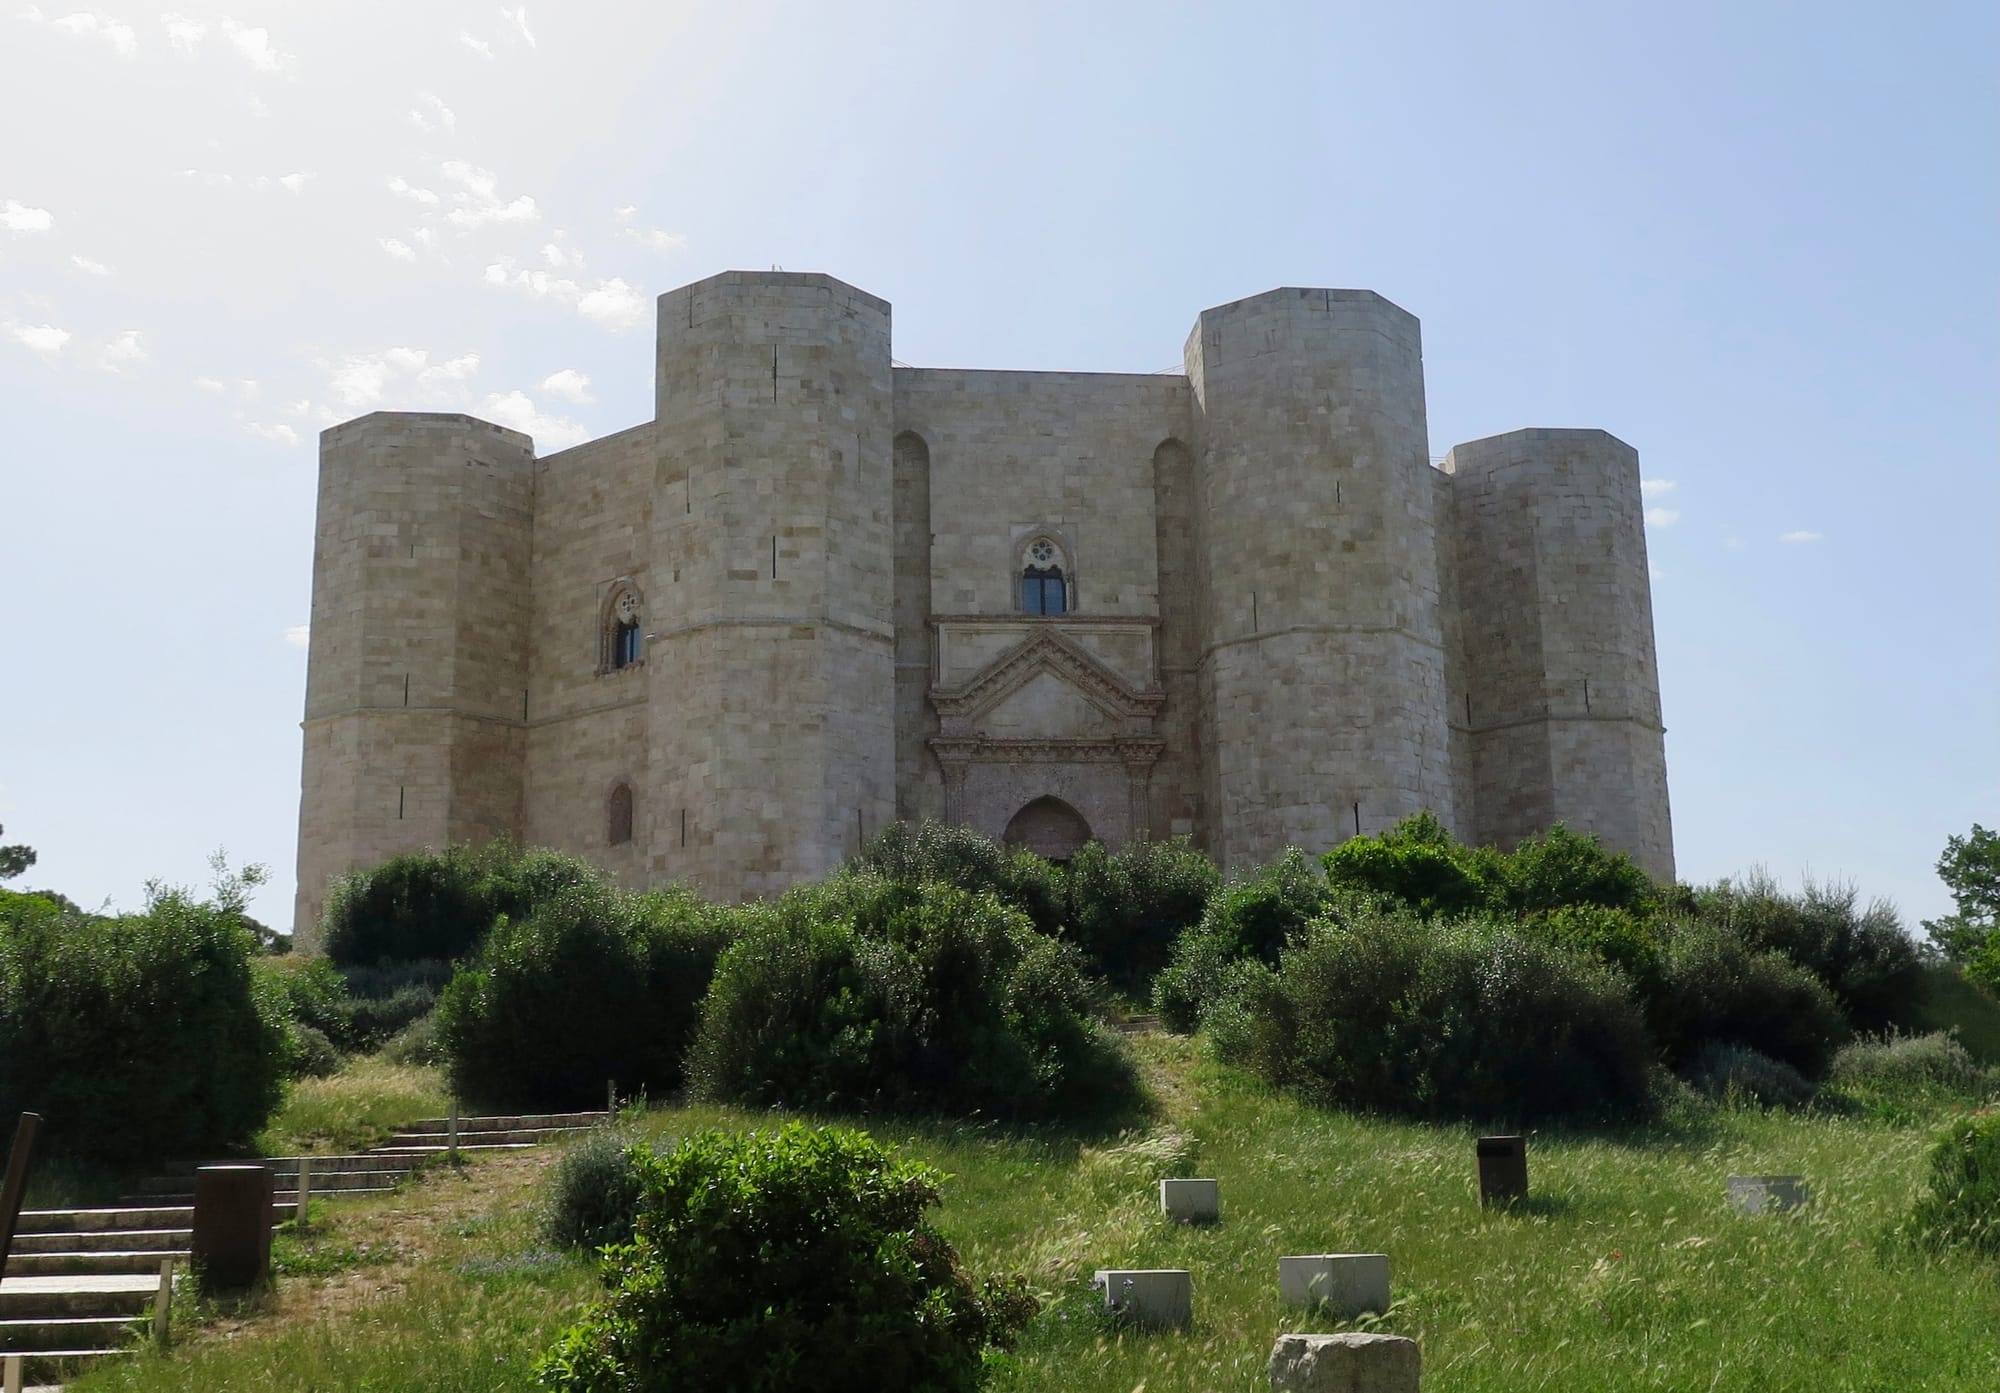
{"left": 0, "top": 0, "right": 2000, "bottom": 929}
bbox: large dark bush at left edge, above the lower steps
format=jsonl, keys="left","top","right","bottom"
{"left": 0, "top": 881, "right": 288, "bottom": 1163}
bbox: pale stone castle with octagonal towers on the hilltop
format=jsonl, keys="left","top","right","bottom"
{"left": 296, "top": 272, "right": 1674, "bottom": 945}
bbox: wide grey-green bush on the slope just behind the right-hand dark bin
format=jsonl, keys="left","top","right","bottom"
{"left": 1224, "top": 909, "right": 1652, "bottom": 1119}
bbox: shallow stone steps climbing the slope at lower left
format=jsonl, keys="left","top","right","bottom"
{"left": 0, "top": 1113, "right": 606, "bottom": 1389}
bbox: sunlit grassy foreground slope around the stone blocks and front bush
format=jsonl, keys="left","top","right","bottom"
{"left": 54, "top": 1035, "right": 2000, "bottom": 1393}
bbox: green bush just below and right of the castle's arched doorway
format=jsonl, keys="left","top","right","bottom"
{"left": 1068, "top": 837, "right": 1222, "bottom": 991}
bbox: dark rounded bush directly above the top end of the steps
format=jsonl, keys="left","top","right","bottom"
{"left": 438, "top": 881, "right": 730, "bottom": 1107}
